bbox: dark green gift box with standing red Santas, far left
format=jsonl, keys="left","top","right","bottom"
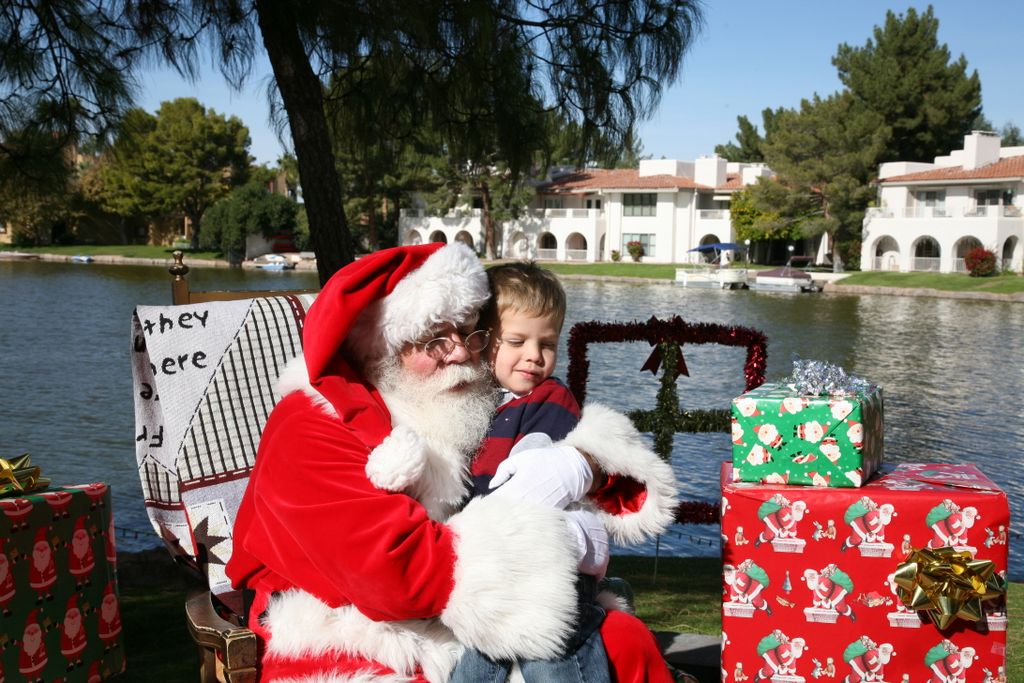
{"left": 0, "top": 483, "right": 125, "bottom": 683}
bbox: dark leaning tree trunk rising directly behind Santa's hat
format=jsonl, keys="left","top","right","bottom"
{"left": 256, "top": 0, "right": 354, "bottom": 286}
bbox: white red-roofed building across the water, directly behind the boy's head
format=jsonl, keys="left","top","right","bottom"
{"left": 399, "top": 156, "right": 770, "bottom": 263}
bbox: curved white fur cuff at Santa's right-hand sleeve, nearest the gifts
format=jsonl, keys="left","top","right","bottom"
{"left": 556, "top": 403, "right": 678, "bottom": 546}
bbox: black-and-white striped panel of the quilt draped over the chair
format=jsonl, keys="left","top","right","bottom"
{"left": 177, "top": 297, "right": 308, "bottom": 490}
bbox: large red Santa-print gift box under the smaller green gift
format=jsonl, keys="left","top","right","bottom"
{"left": 722, "top": 464, "right": 1010, "bottom": 683}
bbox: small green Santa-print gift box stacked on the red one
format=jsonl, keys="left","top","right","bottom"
{"left": 732, "top": 383, "right": 883, "bottom": 487}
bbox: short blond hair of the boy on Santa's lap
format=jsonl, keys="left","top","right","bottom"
{"left": 480, "top": 261, "right": 565, "bottom": 332}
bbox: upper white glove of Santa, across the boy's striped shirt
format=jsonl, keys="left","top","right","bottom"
{"left": 490, "top": 445, "right": 594, "bottom": 509}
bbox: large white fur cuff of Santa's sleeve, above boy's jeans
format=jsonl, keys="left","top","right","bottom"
{"left": 441, "top": 496, "right": 577, "bottom": 659}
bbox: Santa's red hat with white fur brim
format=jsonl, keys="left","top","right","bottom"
{"left": 302, "top": 242, "right": 488, "bottom": 386}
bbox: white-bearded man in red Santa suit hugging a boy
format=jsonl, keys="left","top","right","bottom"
{"left": 227, "top": 244, "right": 673, "bottom": 682}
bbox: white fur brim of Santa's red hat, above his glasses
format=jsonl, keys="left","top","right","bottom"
{"left": 380, "top": 242, "right": 490, "bottom": 352}
